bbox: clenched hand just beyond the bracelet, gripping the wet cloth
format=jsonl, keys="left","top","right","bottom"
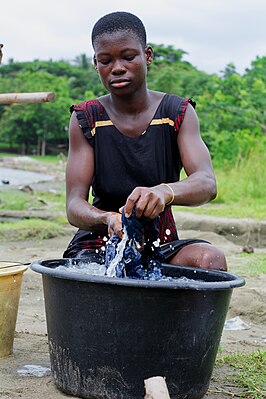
{"left": 121, "top": 185, "right": 165, "bottom": 219}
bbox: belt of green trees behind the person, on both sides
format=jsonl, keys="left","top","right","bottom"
{"left": 0, "top": 48, "right": 266, "bottom": 164}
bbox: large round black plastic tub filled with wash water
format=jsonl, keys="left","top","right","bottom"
{"left": 31, "top": 259, "right": 245, "bottom": 399}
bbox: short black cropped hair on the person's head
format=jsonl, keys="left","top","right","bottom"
{"left": 91, "top": 11, "right": 147, "bottom": 48}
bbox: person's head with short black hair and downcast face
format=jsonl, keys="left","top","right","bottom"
{"left": 91, "top": 11, "right": 153, "bottom": 95}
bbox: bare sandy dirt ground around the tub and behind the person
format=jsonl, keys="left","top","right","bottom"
{"left": 0, "top": 157, "right": 266, "bottom": 399}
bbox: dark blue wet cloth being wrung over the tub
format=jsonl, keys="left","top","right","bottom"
{"left": 105, "top": 207, "right": 164, "bottom": 280}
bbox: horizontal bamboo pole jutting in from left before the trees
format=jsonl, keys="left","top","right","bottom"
{"left": 0, "top": 92, "right": 55, "bottom": 104}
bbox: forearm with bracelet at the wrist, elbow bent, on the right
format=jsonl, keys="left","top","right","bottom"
{"left": 162, "top": 172, "right": 217, "bottom": 206}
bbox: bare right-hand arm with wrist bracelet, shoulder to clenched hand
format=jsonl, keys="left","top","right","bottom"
{"left": 122, "top": 104, "right": 216, "bottom": 218}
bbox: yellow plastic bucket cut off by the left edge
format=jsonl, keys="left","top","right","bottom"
{"left": 0, "top": 261, "right": 27, "bottom": 358}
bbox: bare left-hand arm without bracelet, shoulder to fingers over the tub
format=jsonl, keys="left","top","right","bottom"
{"left": 66, "top": 112, "right": 122, "bottom": 236}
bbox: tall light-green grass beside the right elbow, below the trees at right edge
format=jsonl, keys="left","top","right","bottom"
{"left": 174, "top": 144, "right": 266, "bottom": 220}
